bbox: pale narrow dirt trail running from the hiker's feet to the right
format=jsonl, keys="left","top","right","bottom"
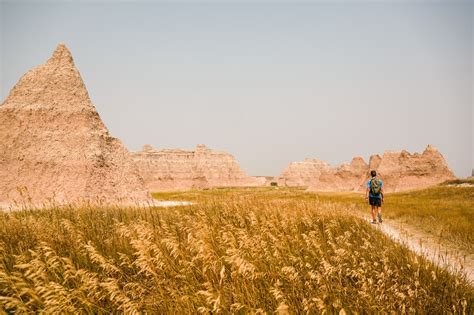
{"left": 364, "top": 215, "right": 474, "bottom": 284}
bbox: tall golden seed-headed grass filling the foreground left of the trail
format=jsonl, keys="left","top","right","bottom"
{"left": 0, "top": 193, "right": 474, "bottom": 314}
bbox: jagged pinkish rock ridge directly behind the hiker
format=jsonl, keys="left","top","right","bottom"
{"left": 279, "top": 145, "right": 455, "bottom": 192}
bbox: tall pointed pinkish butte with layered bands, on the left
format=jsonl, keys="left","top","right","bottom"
{"left": 0, "top": 44, "right": 147, "bottom": 203}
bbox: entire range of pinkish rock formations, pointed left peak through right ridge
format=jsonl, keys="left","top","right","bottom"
{"left": 0, "top": 44, "right": 454, "bottom": 204}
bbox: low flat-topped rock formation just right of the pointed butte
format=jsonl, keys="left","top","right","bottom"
{"left": 132, "top": 145, "right": 260, "bottom": 191}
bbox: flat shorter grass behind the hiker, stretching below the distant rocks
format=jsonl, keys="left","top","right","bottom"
{"left": 153, "top": 185, "right": 474, "bottom": 251}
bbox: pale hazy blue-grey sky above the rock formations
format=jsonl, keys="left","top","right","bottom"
{"left": 0, "top": 0, "right": 474, "bottom": 176}
